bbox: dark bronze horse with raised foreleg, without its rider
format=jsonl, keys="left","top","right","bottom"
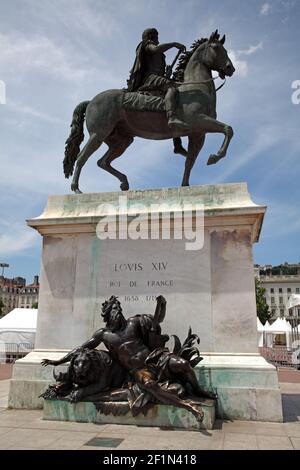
{"left": 64, "top": 31, "right": 235, "bottom": 193}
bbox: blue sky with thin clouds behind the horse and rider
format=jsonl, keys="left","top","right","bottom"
{"left": 0, "top": 0, "right": 300, "bottom": 281}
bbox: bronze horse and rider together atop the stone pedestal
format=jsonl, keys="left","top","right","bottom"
{"left": 64, "top": 28, "right": 235, "bottom": 193}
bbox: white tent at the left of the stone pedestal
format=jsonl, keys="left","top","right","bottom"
{"left": 0, "top": 308, "right": 38, "bottom": 352}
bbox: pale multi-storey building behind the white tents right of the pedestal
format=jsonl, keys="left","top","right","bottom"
{"left": 254, "top": 263, "right": 300, "bottom": 319}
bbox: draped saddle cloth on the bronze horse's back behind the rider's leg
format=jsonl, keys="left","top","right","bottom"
{"left": 122, "top": 91, "right": 166, "bottom": 113}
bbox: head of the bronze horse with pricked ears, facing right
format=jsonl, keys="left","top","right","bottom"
{"left": 202, "top": 30, "right": 235, "bottom": 80}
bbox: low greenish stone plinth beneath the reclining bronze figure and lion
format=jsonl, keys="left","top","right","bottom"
{"left": 43, "top": 399, "right": 216, "bottom": 431}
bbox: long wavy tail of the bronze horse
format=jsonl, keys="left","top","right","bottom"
{"left": 63, "top": 101, "right": 89, "bottom": 178}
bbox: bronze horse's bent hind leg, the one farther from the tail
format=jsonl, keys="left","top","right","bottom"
{"left": 97, "top": 135, "right": 133, "bottom": 191}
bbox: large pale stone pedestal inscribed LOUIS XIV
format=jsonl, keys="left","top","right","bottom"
{"left": 9, "top": 183, "right": 282, "bottom": 421}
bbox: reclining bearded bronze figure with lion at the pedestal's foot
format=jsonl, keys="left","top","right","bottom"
{"left": 42, "top": 296, "right": 216, "bottom": 422}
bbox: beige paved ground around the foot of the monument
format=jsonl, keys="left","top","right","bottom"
{"left": 0, "top": 372, "right": 300, "bottom": 451}
